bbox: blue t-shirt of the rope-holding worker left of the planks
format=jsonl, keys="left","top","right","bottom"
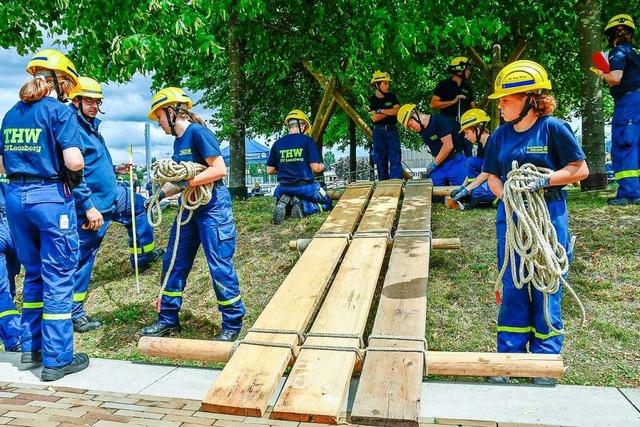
{"left": 171, "top": 123, "right": 222, "bottom": 166}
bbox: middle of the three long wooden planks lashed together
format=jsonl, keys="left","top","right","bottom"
{"left": 272, "top": 181, "right": 402, "bottom": 424}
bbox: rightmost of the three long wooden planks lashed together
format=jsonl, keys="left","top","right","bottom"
{"left": 351, "top": 182, "right": 433, "bottom": 425}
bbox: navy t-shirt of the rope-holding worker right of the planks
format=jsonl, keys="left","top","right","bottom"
{"left": 482, "top": 116, "right": 587, "bottom": 182}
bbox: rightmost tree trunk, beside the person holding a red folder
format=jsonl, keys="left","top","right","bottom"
{"left": 576, "top": 0, "right": 607, "bottom": 191}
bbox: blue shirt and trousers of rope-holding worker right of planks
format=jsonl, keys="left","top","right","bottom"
{"left": 483, "top": 116, "right": 586, "bottom": 354}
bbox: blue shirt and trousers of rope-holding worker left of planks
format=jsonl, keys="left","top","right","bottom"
{"left": 158, "top": 123, "right": 245, "bottom": 332}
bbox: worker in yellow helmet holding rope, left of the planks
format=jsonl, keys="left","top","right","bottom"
{"left": 140, "top": 87, "right": 245, "bottom": 341}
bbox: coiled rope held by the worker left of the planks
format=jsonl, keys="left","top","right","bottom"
{"left": 147, "top": 159, "right": 214, "bottom": 313}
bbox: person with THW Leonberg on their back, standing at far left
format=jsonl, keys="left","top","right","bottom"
{"left": 0, "top": 49, "right": 89, "bottom": 381}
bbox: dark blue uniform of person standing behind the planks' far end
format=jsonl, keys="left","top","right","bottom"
{"left": 369, "top": 92, "right": 402, "bottom": 181}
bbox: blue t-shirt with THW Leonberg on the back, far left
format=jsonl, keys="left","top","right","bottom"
{"left": 0, "top": 96, "right": 82, "bottom": 179}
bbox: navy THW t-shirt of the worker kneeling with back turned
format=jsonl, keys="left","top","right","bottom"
{"left": 267, "top": 133, "right": 320, "bottom": 183}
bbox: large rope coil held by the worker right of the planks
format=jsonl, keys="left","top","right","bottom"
{"left": 497, "top": 161, "right": 586, "bottom": 334}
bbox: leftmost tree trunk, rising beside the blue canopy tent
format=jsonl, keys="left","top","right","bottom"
{"left": 227, "top": 14, "right": 247, "bottom": 200}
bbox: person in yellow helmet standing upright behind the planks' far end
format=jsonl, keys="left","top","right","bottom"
{"left": 369, "top": 71, "right": 402, "bottom": 181}
